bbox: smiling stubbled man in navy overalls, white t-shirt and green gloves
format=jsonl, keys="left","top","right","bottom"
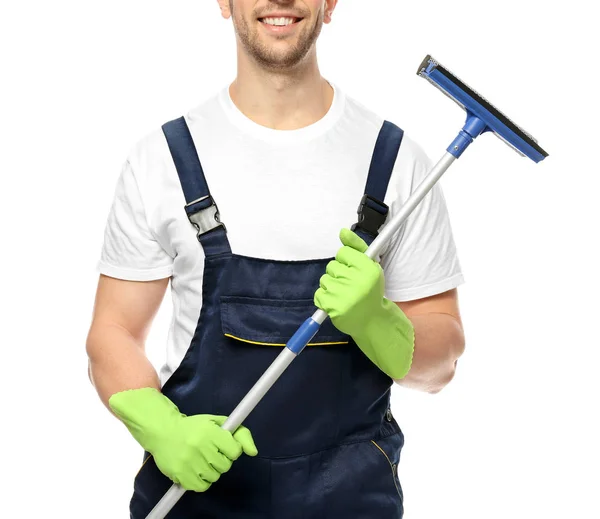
{"left": 87, "top": 0, "right": 464, "bottom": 519}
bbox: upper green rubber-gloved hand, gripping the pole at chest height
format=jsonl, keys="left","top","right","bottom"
{"left": 314, "top": 229, "right": 415, "bottom": 380}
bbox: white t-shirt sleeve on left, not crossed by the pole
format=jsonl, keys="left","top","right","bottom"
{"left": 97, "top": 160, "right": 173, "bottom": 281}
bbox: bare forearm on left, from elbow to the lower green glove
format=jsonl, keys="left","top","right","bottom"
{"left": 86, "top": 323, "right": 160, "bottom": 409}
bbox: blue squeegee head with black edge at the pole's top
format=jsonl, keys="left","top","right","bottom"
{"left": 417, "top": 55, "right": 548, "bottom": 162}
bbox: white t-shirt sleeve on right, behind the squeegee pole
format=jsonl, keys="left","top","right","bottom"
{"left": 380, "top": 136, "right": 464, "bottom": 301}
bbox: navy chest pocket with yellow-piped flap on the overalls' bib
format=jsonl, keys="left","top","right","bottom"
{"left": 218, "top": 295, "right": 355, "bottom": 457}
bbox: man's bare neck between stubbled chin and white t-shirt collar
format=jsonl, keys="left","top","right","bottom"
{"left": 229, "top": 49, "right": 333, "bottom": 130}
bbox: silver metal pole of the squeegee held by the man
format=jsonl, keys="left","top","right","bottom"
{"left": 146, "top": 152, "right": 456, "bottom": 519}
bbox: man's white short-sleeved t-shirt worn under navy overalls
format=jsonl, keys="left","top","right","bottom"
{"left": 98, "top": 82, "right": 464, "bottom": 384}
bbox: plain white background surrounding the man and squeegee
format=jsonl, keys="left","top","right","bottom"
{"left": 0, "top": 0, "right": 600, "bottom": 519}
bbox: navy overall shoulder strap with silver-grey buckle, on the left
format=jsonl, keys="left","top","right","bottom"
{"left": 162, "top": 117, "right": 231, "bottom": 256}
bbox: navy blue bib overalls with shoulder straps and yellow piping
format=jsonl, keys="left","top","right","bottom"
{"left": 130, "top": 117, "right": 404, "bottom": 519}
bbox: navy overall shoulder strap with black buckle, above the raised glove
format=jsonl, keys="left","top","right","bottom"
{"left": 352, "top": 121, "right": 404, "bottom": 244}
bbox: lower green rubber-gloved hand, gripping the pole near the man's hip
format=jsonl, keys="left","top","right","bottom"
{"left": 108, "top": 388, "right": 258, "bottom": 492}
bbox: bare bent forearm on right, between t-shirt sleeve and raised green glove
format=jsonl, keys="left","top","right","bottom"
{"left": 396, "top": 313, "right": 465, "bottom": 393}
